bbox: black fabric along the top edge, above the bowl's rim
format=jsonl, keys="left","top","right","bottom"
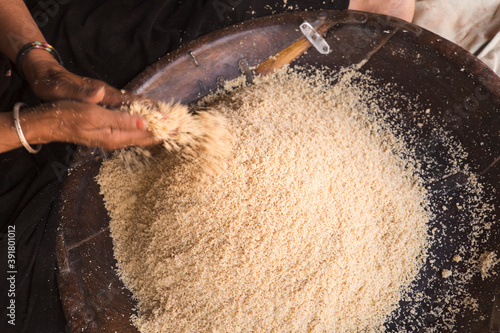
{"left": 21, "top": 0, "right": 349, "bottom": 87}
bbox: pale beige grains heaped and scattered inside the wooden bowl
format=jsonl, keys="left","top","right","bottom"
{"left": 98, "top": 65, "right": 496, "bottom": 332}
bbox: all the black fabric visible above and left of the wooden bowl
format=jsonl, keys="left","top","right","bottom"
{"left": 0, "top": 0, "right": 349, "bottom": 333}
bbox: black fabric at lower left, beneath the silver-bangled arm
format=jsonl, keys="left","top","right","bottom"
{"left": 0, "top": 143, "right": 71, "bottom": 333}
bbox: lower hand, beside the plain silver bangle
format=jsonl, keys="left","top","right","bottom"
{"left": 21, "top": 100, "right": 159, "bottom": 150}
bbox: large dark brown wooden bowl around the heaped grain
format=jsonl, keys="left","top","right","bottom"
{"left": 57, "top": 11, "right": 500, "bottom": 332}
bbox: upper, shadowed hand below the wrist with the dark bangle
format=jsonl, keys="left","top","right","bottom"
{"left": 22, "top": 49, "right": 136, "bottom": 107}
